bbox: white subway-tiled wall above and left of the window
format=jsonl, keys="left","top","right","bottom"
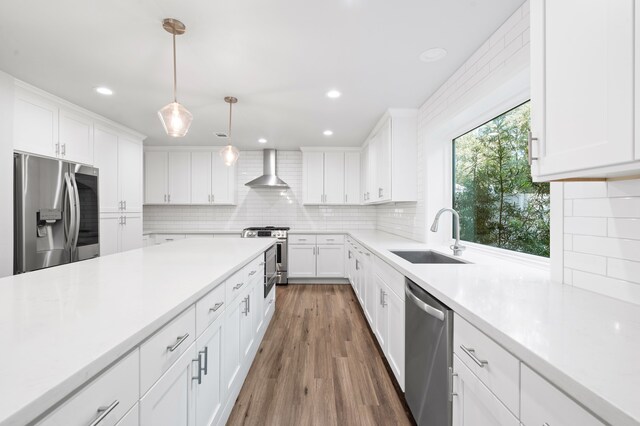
{"left": 377, "top": 2, "right": 529, "bottom": 242}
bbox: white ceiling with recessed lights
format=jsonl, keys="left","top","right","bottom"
{"left": 0, "top": 0, "right": 523, "bottom": 149}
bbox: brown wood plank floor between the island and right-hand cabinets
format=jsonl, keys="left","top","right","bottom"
{"left": 227, "top": 285, "right": 413, "bottom": 426}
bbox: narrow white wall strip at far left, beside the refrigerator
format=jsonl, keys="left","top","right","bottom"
{"left": 0, "top": 71, "right": 14, "bottom": 277}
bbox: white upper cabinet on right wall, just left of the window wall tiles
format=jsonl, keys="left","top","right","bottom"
{"left": 362, "top": 109, "right": 418, "bottom": 204}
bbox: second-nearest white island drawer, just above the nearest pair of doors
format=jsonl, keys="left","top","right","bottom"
{"left": 140, "top": 306, "right": 196, "bottom": 395}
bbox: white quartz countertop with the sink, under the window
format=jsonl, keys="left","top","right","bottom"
{"left": 349, "top": 231, "right": 640, "bottom": 425}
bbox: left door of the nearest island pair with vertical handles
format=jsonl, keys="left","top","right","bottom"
{"left": 140, "top": 342, "right": 198, "bottom": 426}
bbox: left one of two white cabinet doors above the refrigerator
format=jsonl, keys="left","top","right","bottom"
{"left": 13, "top": 88, "right": 59, "bottom": 157}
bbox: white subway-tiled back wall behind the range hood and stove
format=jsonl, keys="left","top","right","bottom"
{"left": 144, "top": 151, "right": 376, "bottom": 231}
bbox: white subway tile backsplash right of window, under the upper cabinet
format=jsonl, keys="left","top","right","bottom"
{"left": 564, "top": 179, "right": 640, "bottom": 304}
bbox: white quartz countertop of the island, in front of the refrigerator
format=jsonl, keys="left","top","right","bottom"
{"left": 0, "top": 238, "right": 276, "bottom": 425}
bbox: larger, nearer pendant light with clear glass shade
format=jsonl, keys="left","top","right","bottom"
{"left": 158, "top": 18, "right": 193, "bottom": 138}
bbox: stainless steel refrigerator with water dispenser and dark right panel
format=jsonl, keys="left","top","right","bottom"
{"left": 13, "top": 153, "right": 100, "bottom": 274}
